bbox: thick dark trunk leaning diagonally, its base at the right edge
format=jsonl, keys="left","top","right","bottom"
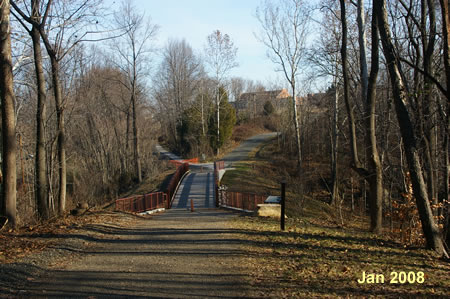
{"left": 373, "top": 0, "right": 448, "bottom": 257}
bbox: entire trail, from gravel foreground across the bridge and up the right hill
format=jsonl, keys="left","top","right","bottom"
{"left": 0, "top": 133, "right": 276, "bottom": 298}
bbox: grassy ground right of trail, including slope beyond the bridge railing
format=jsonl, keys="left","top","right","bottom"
{"left": 222, "top": 139, "right": 450, "bottom": 298}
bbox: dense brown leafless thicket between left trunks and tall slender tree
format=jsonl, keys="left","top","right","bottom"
{"left": 68, "top": 65, "right": 141, "bottom": 199}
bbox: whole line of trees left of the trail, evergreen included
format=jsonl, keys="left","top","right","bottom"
{"left": 0, "top": 0, "right": 243, "bottom": 227}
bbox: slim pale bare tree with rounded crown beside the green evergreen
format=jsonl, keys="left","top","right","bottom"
{"left": 205, "top": 30, "right": 238, "bottom": 155}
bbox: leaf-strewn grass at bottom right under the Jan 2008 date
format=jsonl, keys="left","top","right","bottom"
{"left": 234, "top": 217, "right": 450, "bottom": 298}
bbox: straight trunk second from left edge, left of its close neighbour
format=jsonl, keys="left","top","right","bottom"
{"left": 30, "top": 20, "right": 50, "bottom": 219}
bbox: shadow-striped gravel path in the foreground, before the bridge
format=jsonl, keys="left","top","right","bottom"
{"left": 12, "top": 209, "right": 248, "bottom": 298}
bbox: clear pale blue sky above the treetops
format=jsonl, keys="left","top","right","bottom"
{"left": 105, "top": 0, "right": 281, "bottom": 83}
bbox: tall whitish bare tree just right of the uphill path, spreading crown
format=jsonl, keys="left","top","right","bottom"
{"left": 256, "top": 0, "right": 310, "bottom": 174}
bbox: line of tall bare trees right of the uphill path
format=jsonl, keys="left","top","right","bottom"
{"left": 257, "top": 0, "right": 450, "bottom": 256}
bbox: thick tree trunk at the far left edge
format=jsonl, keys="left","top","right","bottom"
{"left": 0, "top": 1, "right": 16, "bottom": 227}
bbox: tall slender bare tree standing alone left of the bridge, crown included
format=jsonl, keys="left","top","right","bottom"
{"left": 113, "top": 0, "right": 158, "bottom": 183}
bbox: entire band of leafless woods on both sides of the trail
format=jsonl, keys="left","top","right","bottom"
{"left": 0, "top": 0, "right": 450, "bottom": 255}
